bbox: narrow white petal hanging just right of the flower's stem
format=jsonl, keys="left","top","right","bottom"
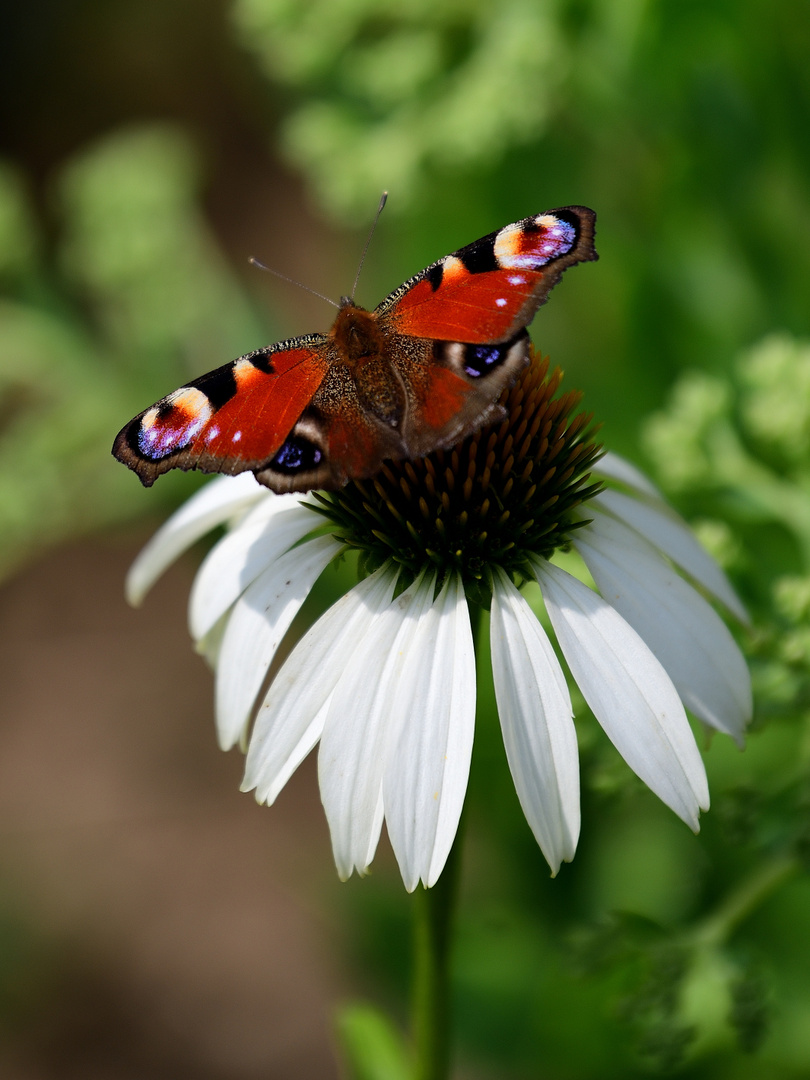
{"left": 489, "top": 569, "right": 580, "bottom": 874}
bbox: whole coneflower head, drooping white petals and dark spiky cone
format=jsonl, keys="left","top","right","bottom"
{"left": 129, "top": 349, "right": 752, "bottom": 890}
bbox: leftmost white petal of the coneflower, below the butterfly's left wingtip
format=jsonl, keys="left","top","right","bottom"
{"left": 126, "top": 473, "right": 266, "bottom": 607}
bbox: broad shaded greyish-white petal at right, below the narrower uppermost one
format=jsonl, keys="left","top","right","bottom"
{"left": 573, "top": 513, "right": 753, "bottom": 745}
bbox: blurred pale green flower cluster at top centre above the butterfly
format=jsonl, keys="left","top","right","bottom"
{"left": 234, "top": 0, "right": 570, "bottom": 218}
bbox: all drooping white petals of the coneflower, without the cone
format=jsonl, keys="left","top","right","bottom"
{"left": 127, "top": 455, "right": 751, "bottom": 890}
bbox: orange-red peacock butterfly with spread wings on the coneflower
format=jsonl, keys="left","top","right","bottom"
{"left": 112, "top": 206, "right": 597, "bottom": 492}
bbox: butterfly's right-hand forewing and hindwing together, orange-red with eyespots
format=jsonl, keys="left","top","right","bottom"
{"left": 375, "top": 206, "right": 598, "bottom": 457}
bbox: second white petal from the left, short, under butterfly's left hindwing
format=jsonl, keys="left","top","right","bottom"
{"left": 189, "top": 495, "right": 321, "bottom": 640}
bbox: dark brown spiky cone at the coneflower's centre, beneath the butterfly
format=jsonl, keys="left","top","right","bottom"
{"left": 308, "top": 353, "right": 602, "bottom": 606}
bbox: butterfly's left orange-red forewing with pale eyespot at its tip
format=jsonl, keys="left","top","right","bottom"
{"left": 112, "top": 334, "right": 328, "bottom": 487}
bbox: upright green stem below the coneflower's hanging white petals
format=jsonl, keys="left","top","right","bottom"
{"left": 413, "top": 837, "right": 461, "bottom": 1080}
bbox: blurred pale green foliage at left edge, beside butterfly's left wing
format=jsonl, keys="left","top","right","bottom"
{"left": 0, "top": 127, "right": 261, "bottom": 573}
